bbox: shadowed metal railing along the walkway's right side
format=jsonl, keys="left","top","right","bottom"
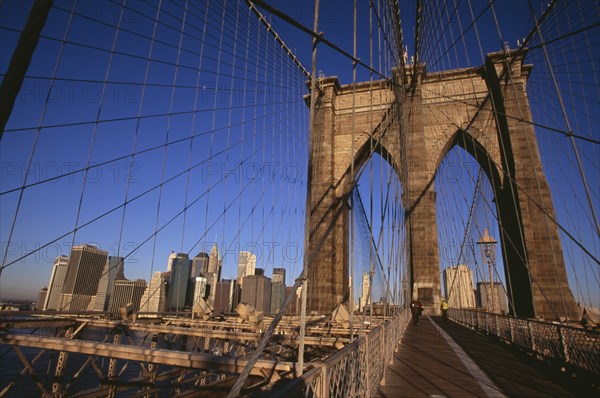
{"left": 448, "top": 309, "right": 600, "bottom": 377}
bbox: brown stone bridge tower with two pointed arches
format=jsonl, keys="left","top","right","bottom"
{"left": 306, "top": 51, "right": 580, "bottom": 319}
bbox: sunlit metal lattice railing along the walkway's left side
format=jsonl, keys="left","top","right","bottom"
{"left": 273, "top": 310, "right": 410, "bottom": 398}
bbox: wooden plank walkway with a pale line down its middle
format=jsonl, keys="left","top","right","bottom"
{"left": 376, "top": 317, "right": 592, "bottom": 398}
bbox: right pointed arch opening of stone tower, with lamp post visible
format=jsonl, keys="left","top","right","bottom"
{"left": 434, "top": 130, "right": 514, "bottom": 313}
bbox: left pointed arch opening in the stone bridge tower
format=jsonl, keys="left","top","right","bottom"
{"left": 348, "top": 140, "right": 407, "bottom": 317}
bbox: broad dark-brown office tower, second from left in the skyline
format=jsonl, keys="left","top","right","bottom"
{"left": 59, "top": 245, "right": 108, "bottom": 311}
